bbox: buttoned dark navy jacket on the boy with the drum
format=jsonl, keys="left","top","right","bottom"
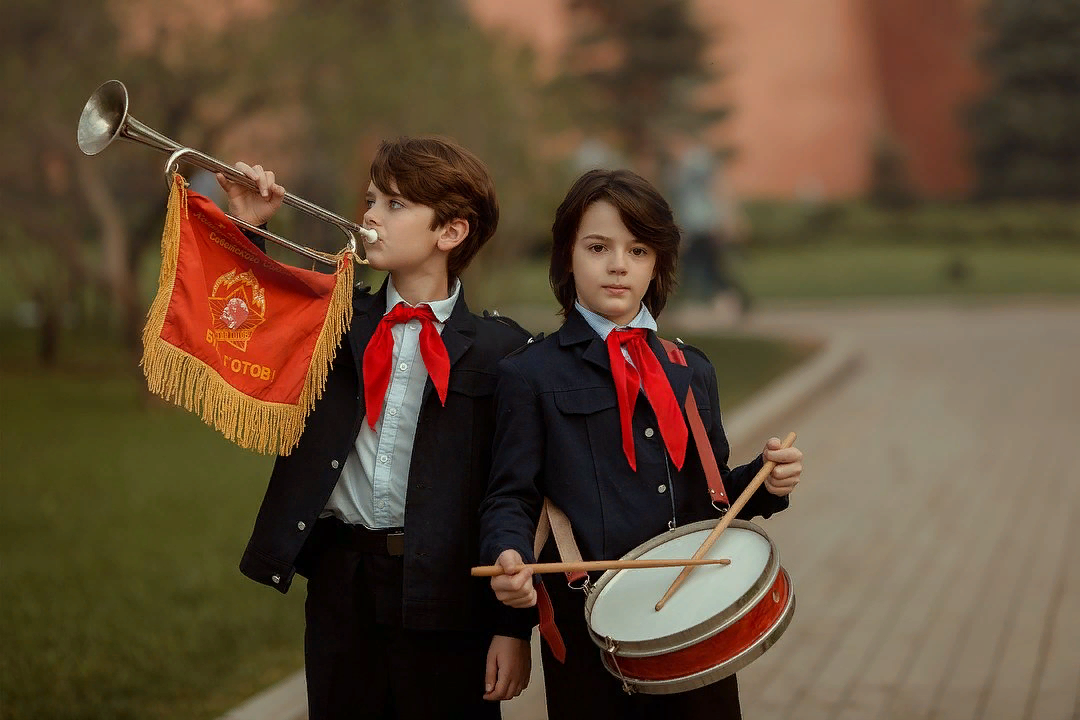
{"left": 481, "top": 310, "right": 787, "bottom": 561}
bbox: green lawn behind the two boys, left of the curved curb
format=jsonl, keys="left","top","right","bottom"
{"left": 0, "top": 325, "right": 809, "bottom": 720}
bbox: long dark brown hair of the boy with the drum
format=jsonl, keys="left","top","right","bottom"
{"left": 548, "top": 169, "right": 680, "bottom": 317}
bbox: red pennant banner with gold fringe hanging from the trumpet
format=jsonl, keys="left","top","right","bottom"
{"left": 141, "top": 175, "right": 353, "bottom": 454}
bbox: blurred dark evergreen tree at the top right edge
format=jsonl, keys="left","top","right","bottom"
{"left": 970, "top": 0, "right": 1080, "bottom": 200}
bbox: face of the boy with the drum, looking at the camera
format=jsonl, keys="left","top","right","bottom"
{"left": 570, "top": 200, "right": 657, "bottom": 325}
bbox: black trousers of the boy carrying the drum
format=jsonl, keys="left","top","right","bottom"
{"left": 542, "top": 575, "right": 742, "bottom": 720}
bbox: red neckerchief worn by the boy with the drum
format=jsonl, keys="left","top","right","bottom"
{"left": 607, "top": 327, "right": 688, "bottom": 472}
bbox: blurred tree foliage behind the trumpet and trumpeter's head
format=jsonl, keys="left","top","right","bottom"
{"left": 0, "top": 0, "right": 565, "bottom": 360}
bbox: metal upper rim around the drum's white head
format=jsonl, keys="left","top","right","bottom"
{"left": 585, "top": 520, "right": 783, "bottom": 657}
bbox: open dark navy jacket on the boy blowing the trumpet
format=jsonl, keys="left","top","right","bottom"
{"left": 240, "top": 276, "right": 535, "bottom": 637}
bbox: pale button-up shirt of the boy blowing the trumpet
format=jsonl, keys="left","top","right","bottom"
{"left": 323, "top": 279, "right": 461, "bottom": 528}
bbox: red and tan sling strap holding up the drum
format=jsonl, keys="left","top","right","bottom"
{"left": 532, "top": 338, "right": 731, "bottom": 663}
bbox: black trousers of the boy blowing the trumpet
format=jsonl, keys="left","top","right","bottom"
{"left": 303, "top": 520, "right": 500, "bottom": 720}
